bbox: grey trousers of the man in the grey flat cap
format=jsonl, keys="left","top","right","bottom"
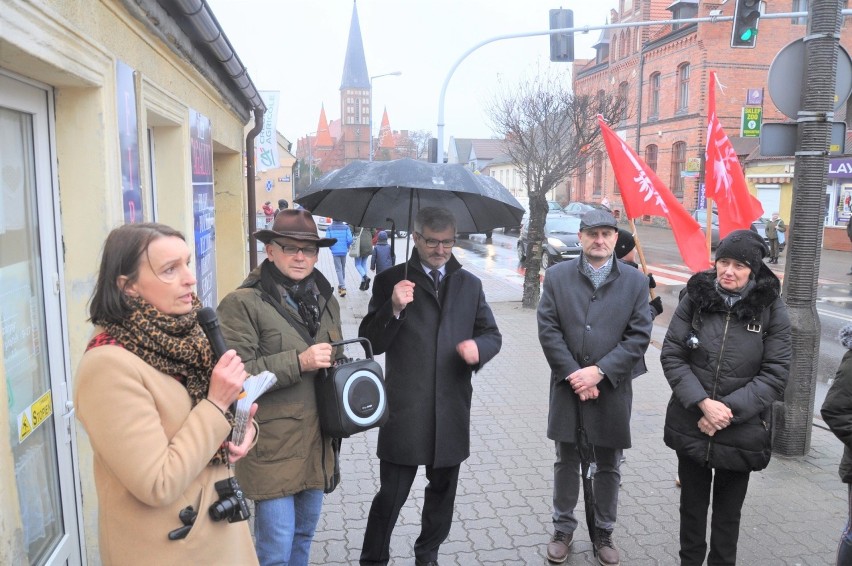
{"left": 553, "top": 441, "right": 622, "bottom": 533}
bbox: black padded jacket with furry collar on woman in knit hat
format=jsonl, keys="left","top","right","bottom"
{"left": 660, "top": 263, "right": 792, "bottom": 472}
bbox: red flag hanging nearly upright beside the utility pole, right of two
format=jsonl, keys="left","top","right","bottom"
{"left": 704, "top": 71, "right": 763, "bottom": 238}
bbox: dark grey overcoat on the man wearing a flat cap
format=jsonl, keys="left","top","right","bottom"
{"left": 538, "top": 258, "right": 652, "bottom": 448}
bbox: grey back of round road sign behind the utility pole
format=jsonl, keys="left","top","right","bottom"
{"left": 764, "top": 38, "right": 852, "bottom": 121}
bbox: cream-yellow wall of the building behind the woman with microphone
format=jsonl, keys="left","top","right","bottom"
{"left": 0, "top": 0, "right": 256, "bottom": 564}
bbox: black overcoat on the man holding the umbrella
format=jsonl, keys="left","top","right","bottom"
{"left": 359, "top": 250, "right": 502, "bottom": 468}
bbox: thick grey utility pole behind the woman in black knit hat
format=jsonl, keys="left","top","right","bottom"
{"left": 773, "top": 0, "right": 843, "bottom": 456}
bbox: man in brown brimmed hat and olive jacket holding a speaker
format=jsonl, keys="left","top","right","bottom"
{"left": 218, "top": 209, "right": 343, "bottom": 565}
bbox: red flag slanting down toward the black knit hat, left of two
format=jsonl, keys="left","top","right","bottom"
{"left": 598, "top": 115, "right": 710, "bottom": 271}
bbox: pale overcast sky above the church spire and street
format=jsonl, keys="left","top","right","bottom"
{"left": 208, "top": 0, "right": 618, "bottom": 151}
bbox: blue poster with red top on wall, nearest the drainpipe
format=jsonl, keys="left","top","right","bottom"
{"left": 189, "top": 110, "right": 218, "bottom": 309}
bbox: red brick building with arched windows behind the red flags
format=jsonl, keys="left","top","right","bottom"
{"left": 569, "top": 0, "right": 852, "bottom": 231}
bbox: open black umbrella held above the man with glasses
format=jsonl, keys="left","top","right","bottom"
{"left": 296, "top": 159, "right": 524, "bottom": 233}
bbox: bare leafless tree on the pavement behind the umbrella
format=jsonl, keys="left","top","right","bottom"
{"left": 489, "top": 74, "right": 628, "bottom": 308}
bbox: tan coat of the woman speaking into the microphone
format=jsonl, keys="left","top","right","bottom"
{"left": 74, "top": 346, "right": 257, "bottom": 566}
